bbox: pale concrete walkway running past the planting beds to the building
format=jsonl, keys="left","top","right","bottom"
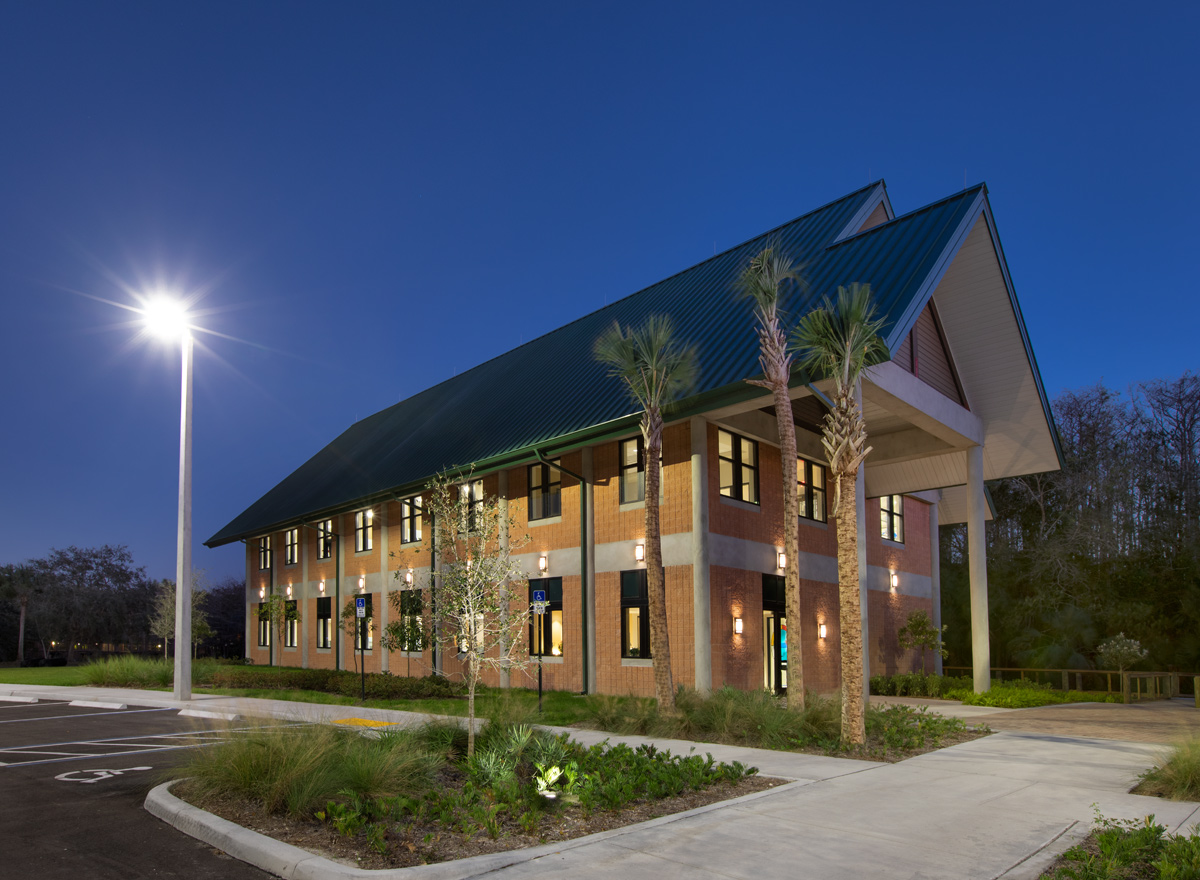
{"left": 0, "top": 684, "right": 1200, "bottom": 880}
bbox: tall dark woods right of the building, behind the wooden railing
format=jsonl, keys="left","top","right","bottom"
{"left": 941, "top": 371, "right": 1200, "bottom": 671}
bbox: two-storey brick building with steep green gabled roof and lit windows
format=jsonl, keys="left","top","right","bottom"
{"left": 206, "top": 181, "right": 1061, "bottom": 694}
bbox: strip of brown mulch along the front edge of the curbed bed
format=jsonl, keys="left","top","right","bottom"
{"left": 172, "top": 776, "right": 787, "bottom": 869}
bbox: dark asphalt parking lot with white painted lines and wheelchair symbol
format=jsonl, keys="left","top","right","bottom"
{"left": 0, "top": 700, "right": 271, "bottom": 880}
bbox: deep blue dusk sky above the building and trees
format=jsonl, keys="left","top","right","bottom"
{"left": 0, "top": 0, "right": 1200, "bottom": 579}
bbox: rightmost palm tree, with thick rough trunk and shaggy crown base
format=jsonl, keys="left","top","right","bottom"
{"left": 792, "top": 285, "right": 888, "bottom": 746}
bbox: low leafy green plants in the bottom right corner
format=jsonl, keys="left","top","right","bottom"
{"left": 1042, "top": 815, "right": 1200, "bottom": 880}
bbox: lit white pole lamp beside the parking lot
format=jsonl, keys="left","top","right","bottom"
{"left": 143, "top": 297, "right": 192, "bottom": 700}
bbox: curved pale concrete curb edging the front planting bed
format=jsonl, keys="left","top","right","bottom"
{"left": 145, "top": 779, "right": 812, "bottom": 880}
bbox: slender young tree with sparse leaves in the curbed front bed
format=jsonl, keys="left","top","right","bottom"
{"left": 422, "top": 474, "right": 529, "bottom": 758}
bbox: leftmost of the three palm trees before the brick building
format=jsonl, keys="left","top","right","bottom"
{"left": 594, "top": 315, "right": 696, "bottom": 714}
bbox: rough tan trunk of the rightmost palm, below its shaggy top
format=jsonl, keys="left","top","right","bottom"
{"left": 838, "top": 468, "right": 866, "bottom": 746}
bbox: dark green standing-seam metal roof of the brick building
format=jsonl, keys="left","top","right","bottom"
{"left": 205, "top": 181, "right": 986, "bottom": 546}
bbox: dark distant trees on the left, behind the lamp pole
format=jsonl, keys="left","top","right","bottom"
{"left": 0, "top": 545, "right": 246, "bottom": 663}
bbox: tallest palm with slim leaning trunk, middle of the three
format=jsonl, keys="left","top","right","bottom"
{"left": 737, "top": 246, "right": 804, "bottom": 710}
